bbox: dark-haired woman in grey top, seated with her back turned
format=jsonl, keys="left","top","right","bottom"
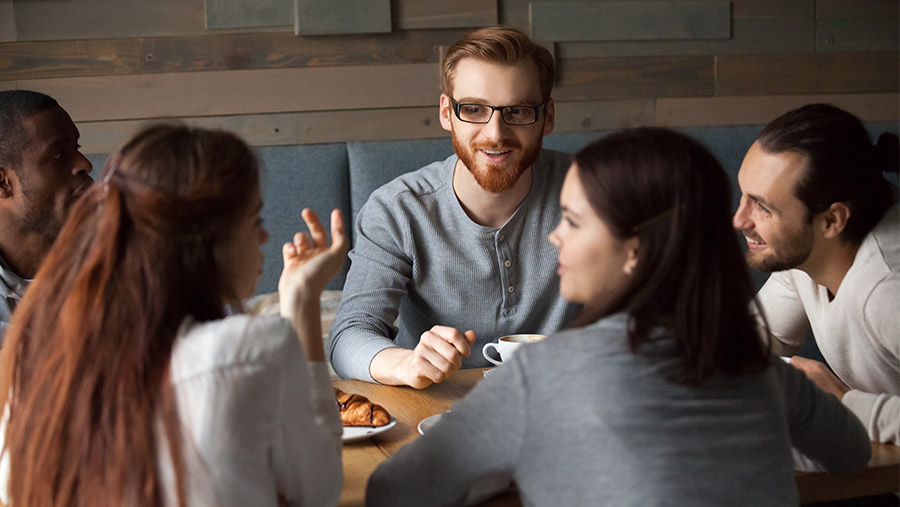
{"left": 367, "top": 129, "right": 871, "bottom": 507}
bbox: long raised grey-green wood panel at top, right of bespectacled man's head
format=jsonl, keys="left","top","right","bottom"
{"left": 531, "top": 0, "right": 731, "bottom": 41}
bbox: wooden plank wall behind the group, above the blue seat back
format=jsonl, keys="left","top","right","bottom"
{"left": 0, "top": 0, "right": 900, "bottom": 153}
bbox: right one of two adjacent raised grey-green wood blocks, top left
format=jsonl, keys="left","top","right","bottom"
{"left": 294, "top": 0, "right": 391, "bottom": 35}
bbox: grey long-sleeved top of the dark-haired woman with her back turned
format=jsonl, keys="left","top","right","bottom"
{"left": 366, "top": 314, "right": 871, "bottom": 507}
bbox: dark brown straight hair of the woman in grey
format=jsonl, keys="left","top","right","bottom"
{"left": 575, "top": 128, "right": 769, "bottom": 384}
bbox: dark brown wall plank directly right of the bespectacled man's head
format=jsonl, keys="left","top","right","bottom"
{"left": 553, "top": 56, "right": 715, "bottom": 100}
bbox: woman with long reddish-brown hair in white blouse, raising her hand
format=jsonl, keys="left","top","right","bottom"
{"left": 0, "top": 125, "right": 347, "bottom": 507}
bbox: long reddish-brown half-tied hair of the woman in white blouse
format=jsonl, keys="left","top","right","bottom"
{"left": 2, "top": 125, "right": 259, "bottom": 507}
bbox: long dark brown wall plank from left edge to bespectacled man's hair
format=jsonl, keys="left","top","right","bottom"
{"left": 0, "top": 29, "right": 466, "bottom": 80}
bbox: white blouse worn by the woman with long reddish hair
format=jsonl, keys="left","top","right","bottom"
{"left": 0, "top": 315, "right": 342, "bottom": 506}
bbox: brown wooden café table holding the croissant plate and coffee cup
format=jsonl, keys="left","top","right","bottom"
{"left": 334, "top": 369, "right": 900, "bottom": 507}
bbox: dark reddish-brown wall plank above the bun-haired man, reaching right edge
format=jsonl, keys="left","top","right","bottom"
{"left": 716, "top": 52, "right": 900, "bottom": 95}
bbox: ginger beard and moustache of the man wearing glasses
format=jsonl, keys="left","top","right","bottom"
{"left": 453, "top": 128, "right": 543, "bottom": 194}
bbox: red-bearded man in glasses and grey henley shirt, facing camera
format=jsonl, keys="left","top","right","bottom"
{"left": 330, "top": 27, "right": 578, "bottom": 388}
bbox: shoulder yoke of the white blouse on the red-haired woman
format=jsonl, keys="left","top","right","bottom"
{"left": 172, "top": 314, "right": 304, "bottom": 378}
